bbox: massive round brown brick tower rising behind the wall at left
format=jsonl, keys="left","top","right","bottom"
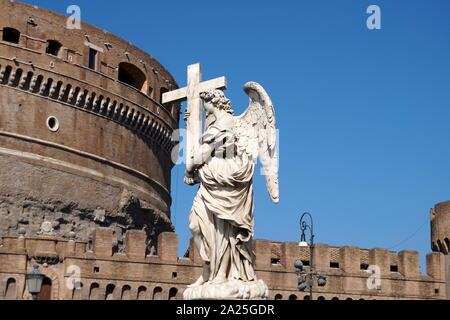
{"left": 0, "top": 0, "right": 179, "bottom": 248}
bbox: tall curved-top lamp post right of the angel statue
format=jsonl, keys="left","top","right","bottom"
{"left": 294, "top": 212, "right": 327, "bottom": 300}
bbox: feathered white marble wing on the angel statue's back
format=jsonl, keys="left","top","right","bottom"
{"left": 235, "top": 82, "right": 280, "bottom": 203}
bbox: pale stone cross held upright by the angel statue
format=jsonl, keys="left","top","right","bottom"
{"left": 162, "top": 63, "right": 227, "bottom": 168}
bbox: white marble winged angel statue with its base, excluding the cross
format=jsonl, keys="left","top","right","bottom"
{"left": 184, "top": 82, "right": 279, "bottom": 300}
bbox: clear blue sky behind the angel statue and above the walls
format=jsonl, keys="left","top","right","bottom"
{"left": 22, "top": 0, "right": 450, "bottom": 270}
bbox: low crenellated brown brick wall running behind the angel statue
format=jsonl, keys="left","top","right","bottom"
{"left": 0, "top": 228, "right": 446, "bottom": 299}
